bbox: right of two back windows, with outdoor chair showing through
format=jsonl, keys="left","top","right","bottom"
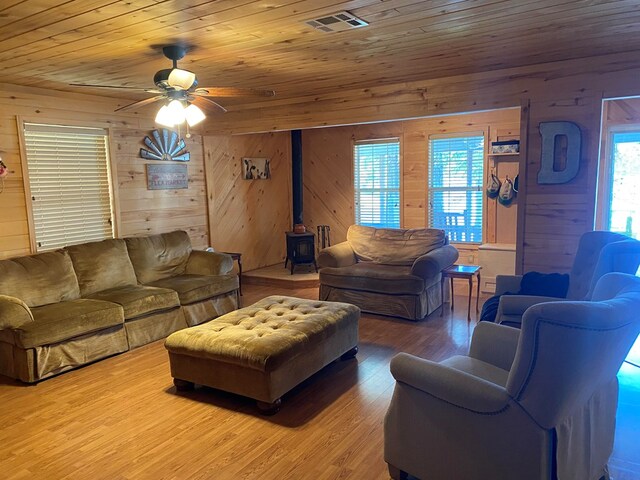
{"left": 428, "top": 133, "right": 484, "bottom": 243}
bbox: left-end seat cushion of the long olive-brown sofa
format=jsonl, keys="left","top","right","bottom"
{"left": 15, "top": 298, "right": 124, "bottom": 348}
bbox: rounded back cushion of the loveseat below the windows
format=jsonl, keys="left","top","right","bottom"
{"left": 347, "top": 225, "right": 446, "bottom": 265}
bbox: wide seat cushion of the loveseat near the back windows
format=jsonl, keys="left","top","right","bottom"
{"left": 320, "top": 262, "right": 425, "bottom": 295}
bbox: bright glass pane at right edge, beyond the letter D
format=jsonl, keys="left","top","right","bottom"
{"left": 607, "top": 131, "right": 640, "bottom": 238}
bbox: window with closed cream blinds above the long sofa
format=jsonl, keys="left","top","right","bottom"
{"left": 24, "top": 123, "right": 113, "bottom": 251}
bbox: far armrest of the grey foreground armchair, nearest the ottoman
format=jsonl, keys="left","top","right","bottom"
{"left": 469, "top": 322, "right": 520, "bottom": 370}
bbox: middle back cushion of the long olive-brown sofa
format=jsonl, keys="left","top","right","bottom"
{"left": 65, "top": 238, "right": 138, "bottom": 297}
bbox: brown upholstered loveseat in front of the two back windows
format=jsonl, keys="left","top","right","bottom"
{"left": 318, "top": 225, "right": 458, "bottom": 320}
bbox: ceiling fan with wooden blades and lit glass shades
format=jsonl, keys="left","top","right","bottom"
{"left": 70, "top": 45, "right": 275, "bottom": 126}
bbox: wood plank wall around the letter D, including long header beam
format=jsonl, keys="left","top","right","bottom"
{"left": 211, "top": 52, "right": 640, "bottom": 272}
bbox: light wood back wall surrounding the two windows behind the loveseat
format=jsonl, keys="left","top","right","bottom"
{"left": 302, "top": 108, "right": 520, "bottom": 261}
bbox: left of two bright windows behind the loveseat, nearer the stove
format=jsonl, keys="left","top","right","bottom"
{"left": 354, "top": 138, "right": 400, "bottom": 228}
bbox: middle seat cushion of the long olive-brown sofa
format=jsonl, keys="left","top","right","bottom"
{"left": 89, "top": 285, "right": 180, "bottom": 320}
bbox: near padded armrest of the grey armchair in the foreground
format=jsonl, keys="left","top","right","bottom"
{"left": 391, "top": 353, "right": 510, "bottom": 414}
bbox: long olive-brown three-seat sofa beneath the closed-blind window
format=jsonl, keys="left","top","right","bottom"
{"left": 0, "top": 231, "right": 238, "bottom": 382}
